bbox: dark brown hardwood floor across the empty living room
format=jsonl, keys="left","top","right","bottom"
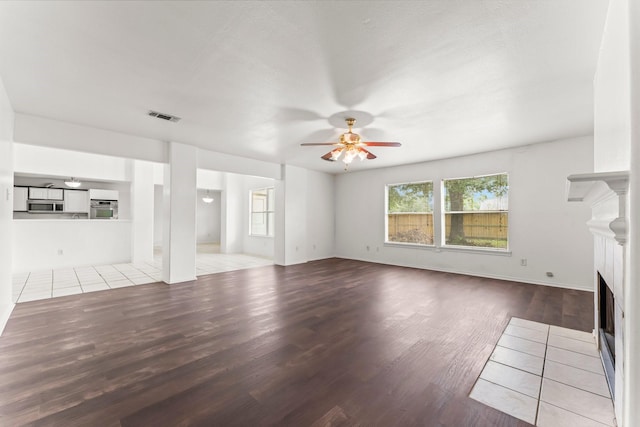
{"left": 0, "top": 259, "right": 593, "bottom": 427}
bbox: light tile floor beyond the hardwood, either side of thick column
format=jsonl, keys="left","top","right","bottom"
{"left": 13, "top": 252, "right": 273, "bottom": 303}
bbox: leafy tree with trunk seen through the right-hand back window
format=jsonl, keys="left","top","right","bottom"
{"left": 444, "top": 174, "right": 509, "bottom": 245}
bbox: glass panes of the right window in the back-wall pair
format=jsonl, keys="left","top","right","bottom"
{"left": 442, "top": 174, "right": 509, "bottom": 249}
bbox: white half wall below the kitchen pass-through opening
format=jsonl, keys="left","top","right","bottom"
{"left": 13, "top": 219, "right": 131, "bottom": 273}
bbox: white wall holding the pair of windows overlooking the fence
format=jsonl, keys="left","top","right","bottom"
{"left": 335, "top": 137, "right": 593, "bottom": 290}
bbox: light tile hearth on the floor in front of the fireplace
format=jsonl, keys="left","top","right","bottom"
{"left": 469, "top": 317, "right": 616, "bottom": 427}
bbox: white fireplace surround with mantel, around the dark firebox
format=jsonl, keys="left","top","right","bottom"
{"left": 567, "top": 171, "right": 631, "bottom": 427}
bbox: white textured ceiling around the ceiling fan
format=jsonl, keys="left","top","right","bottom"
{"left": 0, "top": 0, "right": 608, "bottom": 173}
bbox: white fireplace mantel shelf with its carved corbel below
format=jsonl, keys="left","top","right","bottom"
{"left": 567, "top": 171, "right": 629, "bottom": 245}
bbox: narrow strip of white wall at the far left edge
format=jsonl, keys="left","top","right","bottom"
{"left": 0, "top": 75, "right": 14, "bottom": 334}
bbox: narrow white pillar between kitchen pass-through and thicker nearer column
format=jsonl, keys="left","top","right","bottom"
{"left": 131, "top": 160, "right": 154, "bottom": 264}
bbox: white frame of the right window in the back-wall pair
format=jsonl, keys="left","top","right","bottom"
{"left": 439, "top": 172, "right": 511, "bottom": 251}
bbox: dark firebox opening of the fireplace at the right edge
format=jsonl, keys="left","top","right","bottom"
{"left": 598, "top": 273, "right": 616, "bottom": 397}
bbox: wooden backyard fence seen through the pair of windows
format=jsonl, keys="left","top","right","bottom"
{"left": 388, "top": 212, "right": 508, "bottom": 241}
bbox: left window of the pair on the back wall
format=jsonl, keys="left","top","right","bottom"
{"left": 386, "top": 182, "right": 433, "bottom": 245}
